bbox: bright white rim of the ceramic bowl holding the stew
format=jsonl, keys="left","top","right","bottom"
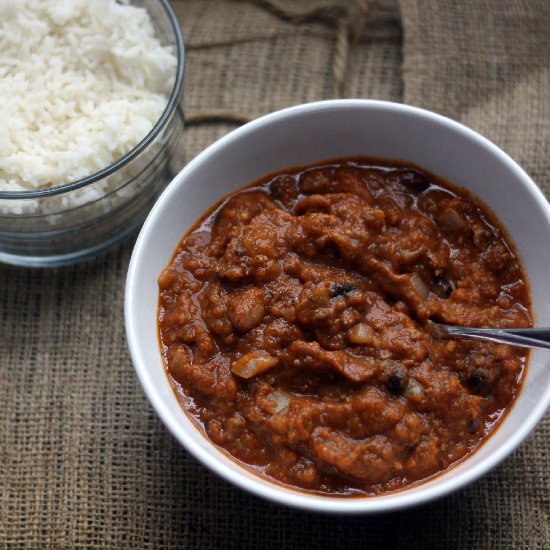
{"left": 124, "top": 99, "right": 550, "bottom": 514}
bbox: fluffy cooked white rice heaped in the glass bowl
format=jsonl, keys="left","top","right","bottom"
{"left": 0, "top": 0, "right": 177, "bottom": 213}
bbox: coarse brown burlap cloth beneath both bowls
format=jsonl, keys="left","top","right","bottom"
{"left": 0, "top": 0, "right": 550, "bottom": 549}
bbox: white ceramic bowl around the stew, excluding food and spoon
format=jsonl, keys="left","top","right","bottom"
{"left": 125, "top": 100, "right": 550, "bottom": 513}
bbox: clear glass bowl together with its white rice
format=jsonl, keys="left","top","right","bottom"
{"left": 0, "top": 0, "right": 184, "bottom": 266}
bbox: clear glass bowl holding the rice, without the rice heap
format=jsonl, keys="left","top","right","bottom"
{"left": 0, "top": 0, "right": 184, "bottom": 266}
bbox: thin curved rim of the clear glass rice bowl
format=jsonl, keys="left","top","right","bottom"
{"left": 0, "top": 0, "right": 185, "bottom": 200}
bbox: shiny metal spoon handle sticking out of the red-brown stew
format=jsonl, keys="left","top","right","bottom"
{"left": 428, "top": 321, "right": 550, "bottom": 350}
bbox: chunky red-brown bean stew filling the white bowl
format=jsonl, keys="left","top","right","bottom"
{"left": 159, "top": 158, "right": 531, "bottom": 495}
